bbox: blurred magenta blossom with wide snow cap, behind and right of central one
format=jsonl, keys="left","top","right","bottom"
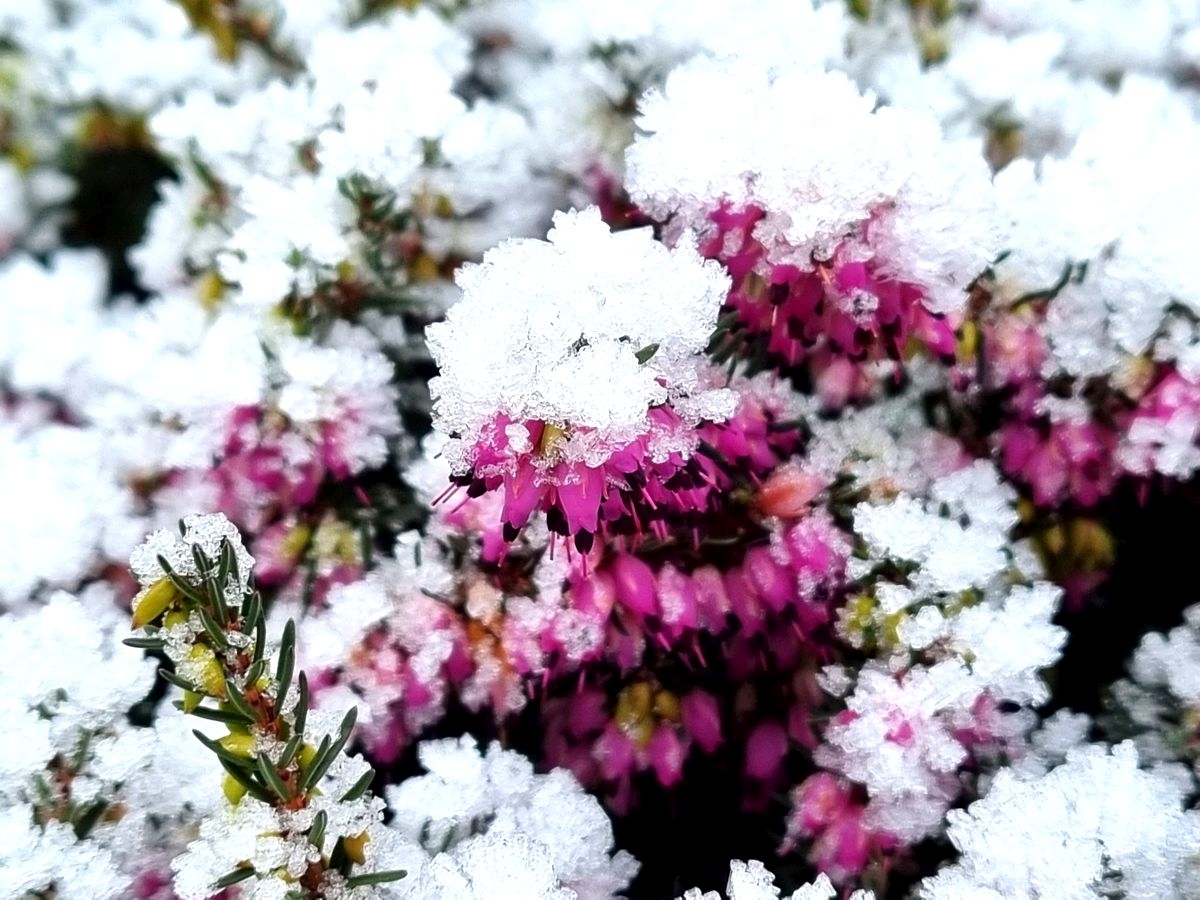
{"left": 629, "top": 60, "right": 994, "bottom": 381}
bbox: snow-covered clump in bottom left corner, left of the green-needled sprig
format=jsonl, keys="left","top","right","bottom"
{"left": 0, "top": 584, "right": 217, "bottom": 900}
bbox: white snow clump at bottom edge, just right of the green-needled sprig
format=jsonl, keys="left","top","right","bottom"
{"left": 388, "top": 737, "right": 637, "bottom": 900}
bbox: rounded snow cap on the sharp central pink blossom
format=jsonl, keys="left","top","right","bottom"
{"left": 427, "top": 208, "right": 733, "bottom": 472}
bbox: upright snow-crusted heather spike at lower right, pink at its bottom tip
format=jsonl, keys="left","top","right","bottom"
{"left": 788, "top": 463, "right": 1066, "bottom": 877}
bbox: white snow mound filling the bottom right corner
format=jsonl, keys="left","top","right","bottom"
{"left": 920, "top": 743, "right": 1200, "bottom": 900}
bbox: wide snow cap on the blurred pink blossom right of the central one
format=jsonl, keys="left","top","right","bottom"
{"left": 626, "top": 59, "right": 996, "bottom": 312}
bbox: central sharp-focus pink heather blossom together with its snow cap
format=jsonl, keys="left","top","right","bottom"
{"left": 428, "top": 210, "right": 733, "bottom": 552}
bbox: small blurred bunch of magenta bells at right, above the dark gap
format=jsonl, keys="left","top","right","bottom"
{"left": 1000, "top": 421, "right": 1117, "bottom": 506}
